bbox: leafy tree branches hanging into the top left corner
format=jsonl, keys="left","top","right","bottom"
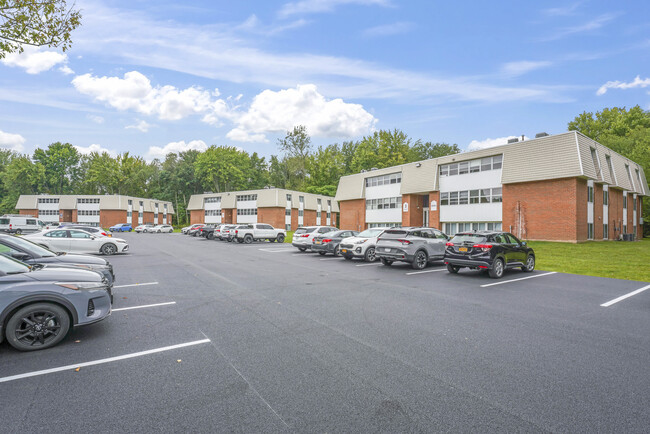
{"left": 0, "top": 0, "right": 81, "bottom": 59}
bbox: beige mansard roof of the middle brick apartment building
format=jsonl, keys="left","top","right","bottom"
{"left": 187, "top": 188, "right": 339, "bottom": 212}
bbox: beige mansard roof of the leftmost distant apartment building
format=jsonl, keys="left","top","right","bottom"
{"left": 16, "top": 194, "right": 175, "bottom": 214}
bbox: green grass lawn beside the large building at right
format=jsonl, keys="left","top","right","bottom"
{"left": 528, "top": 238, "right": 650, "bottom": 282}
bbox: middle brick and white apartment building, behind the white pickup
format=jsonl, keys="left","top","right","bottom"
{"left": 187, "top": 188, "right": 339, "bottom": 230}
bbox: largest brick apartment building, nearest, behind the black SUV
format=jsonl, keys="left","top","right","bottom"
{"left": 336, "top": 131, "right": 648, "bottom": 242}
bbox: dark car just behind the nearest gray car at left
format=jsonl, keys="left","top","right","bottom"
{"left": 0, "top": 234, "right": 115, "bottom": 286}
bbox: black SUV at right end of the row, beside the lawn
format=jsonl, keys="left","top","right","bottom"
{"left": 445, "top": 231, "right": 535, "bottom": 279}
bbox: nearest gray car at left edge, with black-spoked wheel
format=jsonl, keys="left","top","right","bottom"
{"left": 0, "top": 255, "right": 112, "bottom": 351}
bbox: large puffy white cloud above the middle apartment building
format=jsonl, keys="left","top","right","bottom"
{"left": 227, "top": 84, "right": 377, "bottom": 141}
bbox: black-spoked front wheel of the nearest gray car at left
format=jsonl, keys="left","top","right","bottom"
{"left": 5, "top": 303, "right": 70, "bottom": 351}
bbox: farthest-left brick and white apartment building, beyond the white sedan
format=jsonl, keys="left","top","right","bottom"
{"left": 16, "top": 194, "right": 174, "bottom": 228}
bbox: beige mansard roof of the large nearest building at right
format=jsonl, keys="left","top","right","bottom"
{"left": 336, "top": 131, "right": 650, "bottom": 201}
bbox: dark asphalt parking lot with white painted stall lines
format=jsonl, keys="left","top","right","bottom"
{"left": 0, "top": 233, "right": 650, "bottom": 432}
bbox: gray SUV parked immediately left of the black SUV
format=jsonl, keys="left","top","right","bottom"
{"left": 376, "top": 228, "right": 449, "bottom": 270}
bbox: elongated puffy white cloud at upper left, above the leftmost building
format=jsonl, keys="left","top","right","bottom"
{"left": 72, "top": 71, "right": 233, "bottom": 123}
